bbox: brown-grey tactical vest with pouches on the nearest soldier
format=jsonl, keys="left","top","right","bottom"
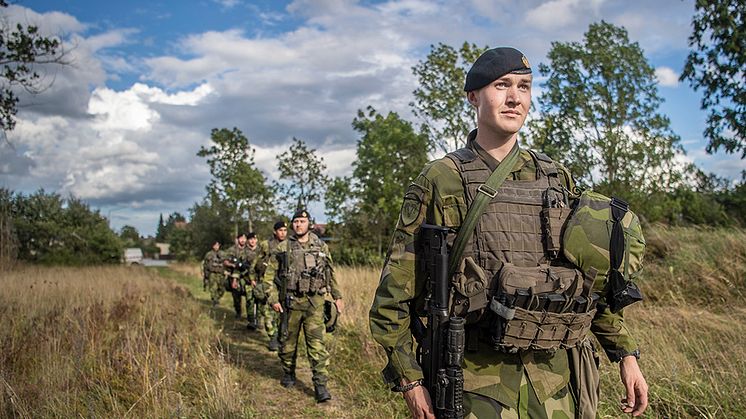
{"left": 447, "top": 148, "right": 597, "bottom": 352}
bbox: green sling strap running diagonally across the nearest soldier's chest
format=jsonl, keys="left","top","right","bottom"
{"left": 448, "top": 141, "right": 520, "bottom": 278}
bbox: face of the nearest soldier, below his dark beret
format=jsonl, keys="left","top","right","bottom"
{"left": 468, "top": 74, "right": 531, "bottom": 136}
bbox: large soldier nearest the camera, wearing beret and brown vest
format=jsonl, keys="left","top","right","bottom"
{"left": 370, "top": 48, "right": 647, "bottom": 418}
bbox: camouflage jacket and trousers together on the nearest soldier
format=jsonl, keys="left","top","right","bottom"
{"left": 370, "top": 134, "right": 637, "bottom": 418}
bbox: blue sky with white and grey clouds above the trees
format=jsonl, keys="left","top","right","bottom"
{"left": 0, "top": 0, "right": 746, "bottom": 234}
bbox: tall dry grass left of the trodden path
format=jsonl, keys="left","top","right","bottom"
{"left": 0, "top": 267, "right": 252, "bottom": 418}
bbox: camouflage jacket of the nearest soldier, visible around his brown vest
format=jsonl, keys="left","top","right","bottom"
{"left": 370, "top": 130, "right": 637, "bottom": 406}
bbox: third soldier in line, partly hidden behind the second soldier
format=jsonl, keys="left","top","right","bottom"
{"left": 255, "top": 221, "right": 288, "bottom": 352}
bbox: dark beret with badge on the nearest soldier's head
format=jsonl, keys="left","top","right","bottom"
{"left": 464, "top": 47, "right": 531, "bottom": 92}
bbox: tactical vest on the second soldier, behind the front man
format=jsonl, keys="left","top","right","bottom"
{"left": 287, "top": 233, "right": 328, "bottom": 294}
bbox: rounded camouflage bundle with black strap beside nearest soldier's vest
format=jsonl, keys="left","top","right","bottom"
{"left": 562, "top": 190, "right": 645, "bottom": 312}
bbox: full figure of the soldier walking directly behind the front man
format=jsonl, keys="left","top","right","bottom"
{"left": 264, "top": 210, "right": 344, "bottom": 403}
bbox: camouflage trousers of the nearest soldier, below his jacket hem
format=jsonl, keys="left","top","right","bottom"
{"left": 464, "top": 372, "right": 575, "bottom": 419}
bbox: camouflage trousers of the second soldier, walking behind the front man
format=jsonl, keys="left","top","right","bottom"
{"left": 279, "top": 295, "right": 329, "bottom": 385}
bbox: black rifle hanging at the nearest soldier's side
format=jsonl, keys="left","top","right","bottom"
{"left": 412, "top": 224, "right": 465, "bottom": 419}
